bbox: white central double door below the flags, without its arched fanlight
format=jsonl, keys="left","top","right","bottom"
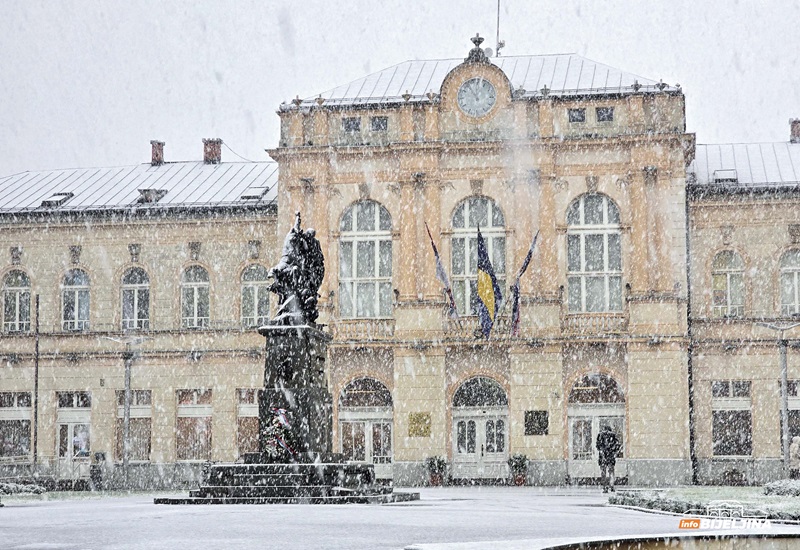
{"left": 453, "top": 410, "right": 508, "bottom": 478}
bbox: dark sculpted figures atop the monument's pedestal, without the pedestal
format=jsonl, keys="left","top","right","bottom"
{"left": 269, "top": 212, "right": 325, "bottom": 327}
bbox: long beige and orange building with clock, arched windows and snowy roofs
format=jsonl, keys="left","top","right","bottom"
{"left": 0, "top": 40, "right": 800, "bottom": 484}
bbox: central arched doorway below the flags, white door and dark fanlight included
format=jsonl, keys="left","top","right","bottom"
{"left": 452, "top": 376, "right": 508, "bottom": 479}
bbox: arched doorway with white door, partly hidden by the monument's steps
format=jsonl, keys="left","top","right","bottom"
{"left": 339, "top": 378, "right": 392, "bottom": 477}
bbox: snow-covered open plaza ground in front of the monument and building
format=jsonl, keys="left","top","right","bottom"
{"left": 0, "top": 487, "right": 800, "bottom": 550}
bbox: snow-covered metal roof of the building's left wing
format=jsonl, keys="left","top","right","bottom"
{"left": 0, "top": 162, "right": 278, "bottom": 214}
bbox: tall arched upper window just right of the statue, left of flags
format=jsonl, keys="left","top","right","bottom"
{"left": 339, "top": 201, "right": 392, "bottom": 318}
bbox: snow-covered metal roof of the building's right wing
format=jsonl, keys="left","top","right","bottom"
{"left": 689, "top": 142, "right": 800, "bottom": 191}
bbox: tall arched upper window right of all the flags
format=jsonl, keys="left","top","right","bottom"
{"left": 567, "top": 193, "right": 622, "bottom": 313}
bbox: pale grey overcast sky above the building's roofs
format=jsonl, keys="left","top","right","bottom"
{"left": 0, "top": 0, "right": 800, "bottom": 175}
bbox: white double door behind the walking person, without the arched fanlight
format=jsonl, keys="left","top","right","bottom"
{"left": 569, "top": 406, "right": 627, "bottom": 478}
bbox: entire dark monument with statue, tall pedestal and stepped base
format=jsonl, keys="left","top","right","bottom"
{"left": 155, "top": 212, "right": 419, "bottom": 504}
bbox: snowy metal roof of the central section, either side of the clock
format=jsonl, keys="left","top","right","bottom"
{"left": 290, "top": 53, "right": 678, "bottom": 107}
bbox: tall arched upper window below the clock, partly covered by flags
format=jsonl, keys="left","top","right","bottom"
{"left": 451, "top": 197, "right": 506, "bottom": 315}
